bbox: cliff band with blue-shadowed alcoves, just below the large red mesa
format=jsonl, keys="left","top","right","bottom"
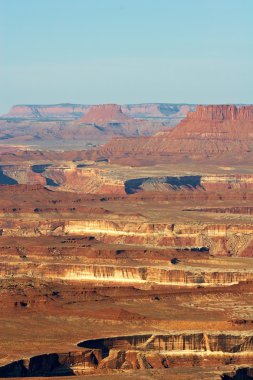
{"left": 3, "top": 160, "right": 253, "bottom": 200}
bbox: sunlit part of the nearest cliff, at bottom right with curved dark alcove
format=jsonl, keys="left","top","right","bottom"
{"left": 79, "top": 332, "right": 252, "bottom": 369}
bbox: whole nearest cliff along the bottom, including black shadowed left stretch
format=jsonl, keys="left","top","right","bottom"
{"left": 0, "top": 332, "right": 253, "bottom": 378}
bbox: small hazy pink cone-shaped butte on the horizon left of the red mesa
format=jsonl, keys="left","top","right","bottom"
{"left": 80, "top": 104, "right": 134, "bottom": 125}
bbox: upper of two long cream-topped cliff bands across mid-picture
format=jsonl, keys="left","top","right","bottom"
{"left": 0, "top": 218, "right": 253, "bottom": 257}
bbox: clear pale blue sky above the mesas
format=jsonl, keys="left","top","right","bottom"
{"left": 0, "top": 0, "right": 253, "bottom": 113}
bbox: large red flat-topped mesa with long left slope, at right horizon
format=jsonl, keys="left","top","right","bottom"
{"left": 90, "top": 105, "right": 253, "bottom": 163}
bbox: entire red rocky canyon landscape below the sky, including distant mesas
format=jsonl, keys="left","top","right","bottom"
{"left": 0, "top": 103, "right": 253, "bottom": 380}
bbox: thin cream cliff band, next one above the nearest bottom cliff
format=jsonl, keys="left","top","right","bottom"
{"left": 0, "top": 260, "right": 253, "bottom": 286}
